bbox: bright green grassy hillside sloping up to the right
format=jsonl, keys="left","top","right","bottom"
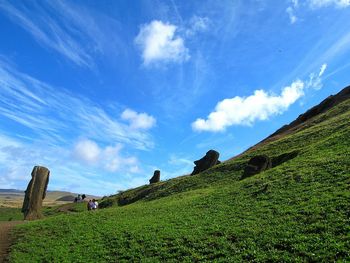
{"left": 6, "top": 100, "right": 350, "bottom": 262}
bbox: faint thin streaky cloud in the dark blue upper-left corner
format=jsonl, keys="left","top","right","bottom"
{"left": 0, "top": 1, "right": 119, "bottom": 68}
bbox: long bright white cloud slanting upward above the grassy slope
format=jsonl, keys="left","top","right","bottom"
{"left": 192, "top": 64, "right": 327, "bottom": 132}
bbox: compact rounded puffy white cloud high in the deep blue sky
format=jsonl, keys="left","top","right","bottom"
{"left": 135, "top": 20, "right": 189, "bottom": 65}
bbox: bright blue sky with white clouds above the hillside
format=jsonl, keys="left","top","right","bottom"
{"left": 0, "top": 0, "right": 350, "bottom": 195}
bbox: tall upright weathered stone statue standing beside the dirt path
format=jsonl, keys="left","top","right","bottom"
{"left": 22, "top": 166, "right": 50, "bottom": 220}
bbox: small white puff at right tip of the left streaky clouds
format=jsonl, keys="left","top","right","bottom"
{"left": 121, "top": 109, "right": 156, "bottom": 130}
